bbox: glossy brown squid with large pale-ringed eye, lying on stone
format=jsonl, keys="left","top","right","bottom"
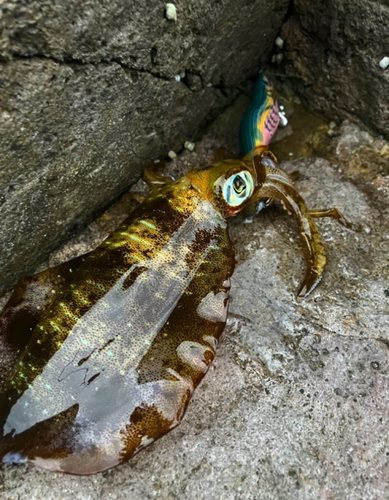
{"left": 0, "top": 73, "right": 348, "bottom": 475}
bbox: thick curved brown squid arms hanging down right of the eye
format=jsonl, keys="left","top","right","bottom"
{"left": 251, "top": 159, "right": 326, "bottom": 298}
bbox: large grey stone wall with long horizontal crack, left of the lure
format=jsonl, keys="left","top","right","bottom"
{"left": 0, "top": 0, "right": 288, "bottom": 292}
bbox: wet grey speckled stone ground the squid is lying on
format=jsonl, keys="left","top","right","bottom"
{"left": 0, "top": 123, "right": 389, "bottom": 500}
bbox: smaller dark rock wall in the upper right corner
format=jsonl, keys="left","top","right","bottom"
{"left": 282, "top": 0, "right": 389, "bottom": 136}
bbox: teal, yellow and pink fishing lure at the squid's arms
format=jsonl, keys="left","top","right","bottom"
{"left": 239, "top": 73, "right": 280, "bottom": 156}
